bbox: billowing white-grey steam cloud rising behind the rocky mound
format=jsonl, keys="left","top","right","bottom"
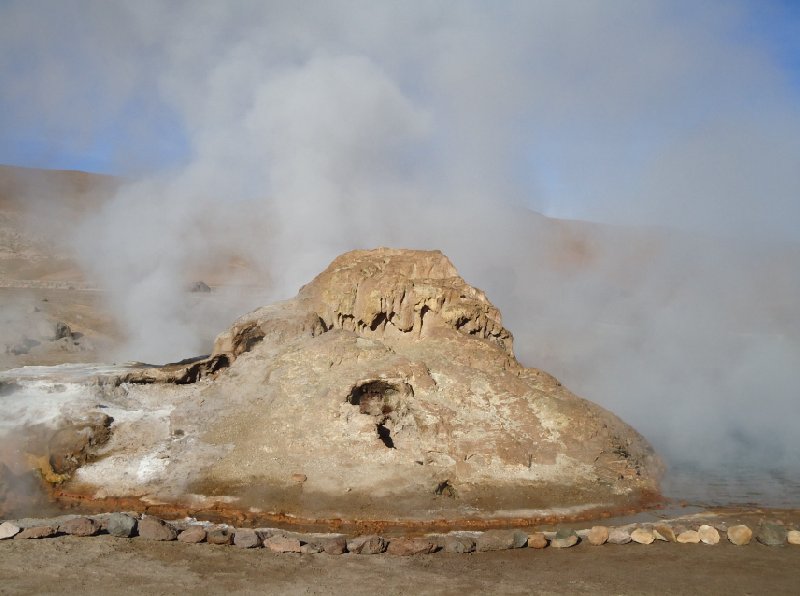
{"left": 0, "top": 0, "right": 800, "bottom": 500}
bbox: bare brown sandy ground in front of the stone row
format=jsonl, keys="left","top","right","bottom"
{"left": 0, "top": 536, "right": 800, "bottom": 596}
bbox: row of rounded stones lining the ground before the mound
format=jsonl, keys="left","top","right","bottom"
{"left": 0, "top": 512, "right": 800, "bottom": 556}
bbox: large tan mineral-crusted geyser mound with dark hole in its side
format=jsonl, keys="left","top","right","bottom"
{"left": 1, "top": 248, "right": 661, "bottom": 526}
